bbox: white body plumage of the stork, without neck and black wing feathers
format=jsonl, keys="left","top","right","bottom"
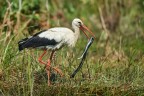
{"left": 38, "top": 27, "right": 79, "bottom": 49}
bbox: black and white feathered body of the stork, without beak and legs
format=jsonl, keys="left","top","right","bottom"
{"left": 18, "top": 19, "right": 82, "bottom": 51}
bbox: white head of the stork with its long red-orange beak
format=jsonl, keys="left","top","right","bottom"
{"left": 72, "top": 18, "right": 96, "bottom": 39}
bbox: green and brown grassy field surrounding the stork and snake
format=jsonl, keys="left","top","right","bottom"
{"left": 0, "top": 0, "right": 144, "bottom": 96}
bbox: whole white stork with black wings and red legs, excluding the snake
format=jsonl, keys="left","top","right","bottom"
{"left": 18, "top": 18, "right": 95, "bottom": 85}
